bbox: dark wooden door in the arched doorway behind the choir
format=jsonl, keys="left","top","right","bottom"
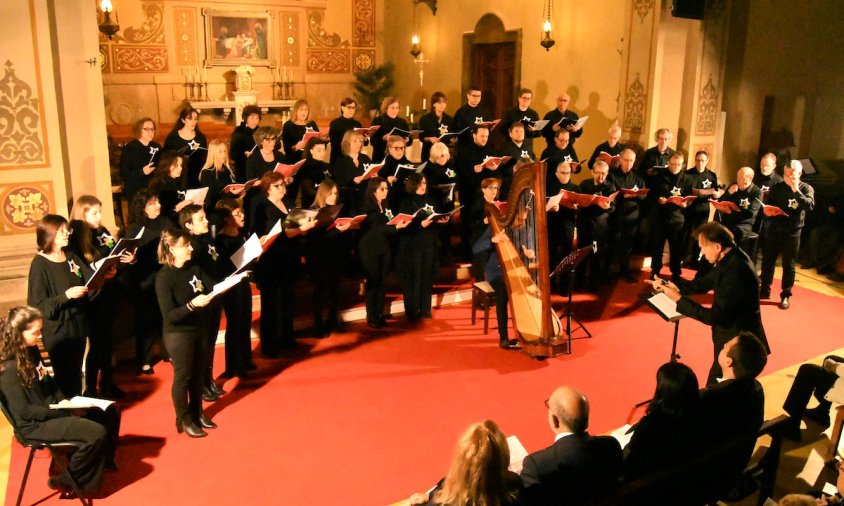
{"left": 471, "top": 42, "right": 516, "bottom": 118}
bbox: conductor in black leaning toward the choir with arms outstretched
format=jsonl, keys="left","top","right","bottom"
{"left": 648, "top": 222, "right": 770, "bottom": 385}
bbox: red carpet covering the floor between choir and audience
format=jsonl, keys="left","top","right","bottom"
{"left": 6, "top": 274, "right": 844, "bottom": 506}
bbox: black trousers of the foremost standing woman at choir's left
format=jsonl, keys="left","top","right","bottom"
{"left": 164, "top": 329, "right": 208, "bottom": 423}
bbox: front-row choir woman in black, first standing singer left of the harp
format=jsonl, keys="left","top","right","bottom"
{"left": 397, "top": 173, "right": 448, "bottom": 322}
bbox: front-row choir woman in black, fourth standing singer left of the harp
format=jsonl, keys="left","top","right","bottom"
{"left": 254, "top": 172, "right": 314, "bottom": 358}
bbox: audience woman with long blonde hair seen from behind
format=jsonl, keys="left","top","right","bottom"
{"left": 409, "top": 420, "right": 522, "bottom": 506}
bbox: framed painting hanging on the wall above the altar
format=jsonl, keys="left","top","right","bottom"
{"left": 202, "top": 8, "right": 276, "bottom": 67}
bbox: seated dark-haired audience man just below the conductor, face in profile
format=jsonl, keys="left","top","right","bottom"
{"left": 700, "top": 332, "right": 768, "bottom": 499}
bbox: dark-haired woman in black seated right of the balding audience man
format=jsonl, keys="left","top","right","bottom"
{"left": 624, "top": 362, "right": 700, "bottom": 482}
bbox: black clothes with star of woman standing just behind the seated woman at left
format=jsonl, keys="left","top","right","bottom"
{"left": 26, "top": 255, "right": 92, "bottom": 397}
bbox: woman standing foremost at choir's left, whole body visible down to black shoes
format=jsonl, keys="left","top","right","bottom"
{"left": 155, "top": 229, "right": 216, "bottom": 437}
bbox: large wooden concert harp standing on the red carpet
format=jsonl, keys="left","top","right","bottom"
{"left": 485, "top": 162, "right": 570, "bottom": 357}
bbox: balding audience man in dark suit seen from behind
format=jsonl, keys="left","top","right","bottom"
{"left": 521, "top": 387, "right": 622, "bottom": 505}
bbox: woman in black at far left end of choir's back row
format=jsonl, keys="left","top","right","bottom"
{"left": 120, "top": 118, "right": 161, "bottom": 202}
